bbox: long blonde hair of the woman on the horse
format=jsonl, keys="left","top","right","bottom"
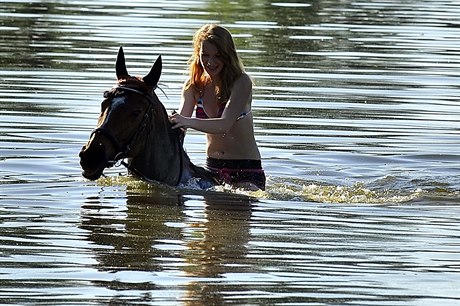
{"left": 187, "top": 24, "right": 244, "bottom": 103}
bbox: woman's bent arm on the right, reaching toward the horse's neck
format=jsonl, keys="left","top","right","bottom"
{"left": 170, "top": 74, "right": 252, "bottom": 134}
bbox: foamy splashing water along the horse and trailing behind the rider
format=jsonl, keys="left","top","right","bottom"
{"left": 97, "top": 175, "right": 430, "bottom": 204}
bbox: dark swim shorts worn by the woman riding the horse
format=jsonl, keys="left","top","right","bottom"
{"left": 206, "top": 157, "right": 265, "bottom": 190}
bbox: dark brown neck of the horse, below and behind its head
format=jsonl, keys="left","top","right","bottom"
{"left": 130, "top": 109, "right": 185, "bottom": 185}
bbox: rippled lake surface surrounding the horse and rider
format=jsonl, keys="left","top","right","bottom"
{"left": 0, "top": 0, "right": 460, "bottom": 306}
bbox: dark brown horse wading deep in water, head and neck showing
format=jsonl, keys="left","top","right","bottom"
{"left": 80, "top": 47, "right": 214, "bottom": 187}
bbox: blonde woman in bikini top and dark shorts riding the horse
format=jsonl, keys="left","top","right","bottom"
{"left": 170, "top": 24, "right": 265, "bottom": 190}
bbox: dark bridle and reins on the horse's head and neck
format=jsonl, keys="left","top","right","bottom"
{"left": 90, "top": 85, "right": 183, "bottom": 186}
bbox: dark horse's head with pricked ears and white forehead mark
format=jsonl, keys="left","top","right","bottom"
{"left": 79, "top": 47, "right": 164, "bottom": 180}
